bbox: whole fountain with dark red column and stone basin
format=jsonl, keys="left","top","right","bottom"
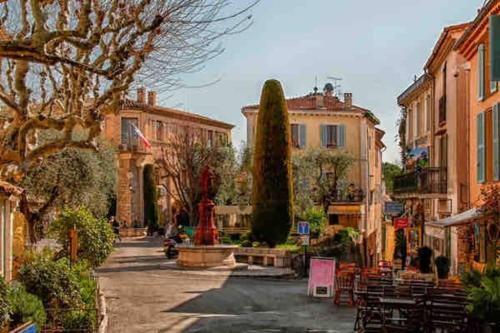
{"left": 177, "top": 168, "right": 237, "bottom": 269}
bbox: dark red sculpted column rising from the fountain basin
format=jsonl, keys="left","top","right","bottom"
{"left": 194, "top": 167, "right": 219, "bottom": 245}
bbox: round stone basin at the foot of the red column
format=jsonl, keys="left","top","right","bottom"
{"left": 176, "top": 244, "right": 238, "bottom": 269}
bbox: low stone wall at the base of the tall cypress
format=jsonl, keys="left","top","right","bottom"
{"left": 234, "top": 247, "right": 292, "bottom": 267}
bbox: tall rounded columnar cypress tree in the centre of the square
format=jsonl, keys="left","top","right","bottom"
{"left": 252, "top": 80, "right": 293, "bottom": 247}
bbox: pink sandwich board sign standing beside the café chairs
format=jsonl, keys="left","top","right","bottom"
{"left": 307, "top": 257, "right": 335, "bottom": 297}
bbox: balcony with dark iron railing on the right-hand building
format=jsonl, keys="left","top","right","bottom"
{"left": 394, "top": 167, "right": 447, "bottom": 195}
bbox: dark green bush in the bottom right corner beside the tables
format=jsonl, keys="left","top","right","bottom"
{"left": 466, "top": 276, "right": 500, "bottom": 324}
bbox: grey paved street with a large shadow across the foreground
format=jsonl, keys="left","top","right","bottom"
{"left": 99, "top": 239, "right": 355, "bottom": 333}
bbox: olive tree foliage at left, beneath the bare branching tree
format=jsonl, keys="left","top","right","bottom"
{"left": 22, "top": 140, "right": 118, "bottom": 217}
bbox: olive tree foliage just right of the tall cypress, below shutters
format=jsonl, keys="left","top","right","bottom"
{"left": 293, "top": 148, "right": 354, "bottom": 216}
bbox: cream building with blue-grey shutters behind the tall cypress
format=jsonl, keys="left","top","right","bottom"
{"left": 242, "top": 86, "right": 385, "bottom": 265}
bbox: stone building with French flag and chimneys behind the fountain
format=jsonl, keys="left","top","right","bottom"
{"left": 103, "top": 88, "right": 234, "bottom": 227}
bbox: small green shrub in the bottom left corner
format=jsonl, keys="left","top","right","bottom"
{"left": 8, "top": 284, "right": 47, "bottom": 331}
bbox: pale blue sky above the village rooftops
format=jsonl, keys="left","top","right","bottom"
{"left": 159, "top": 0, "right": 484, "bottom": 162}
